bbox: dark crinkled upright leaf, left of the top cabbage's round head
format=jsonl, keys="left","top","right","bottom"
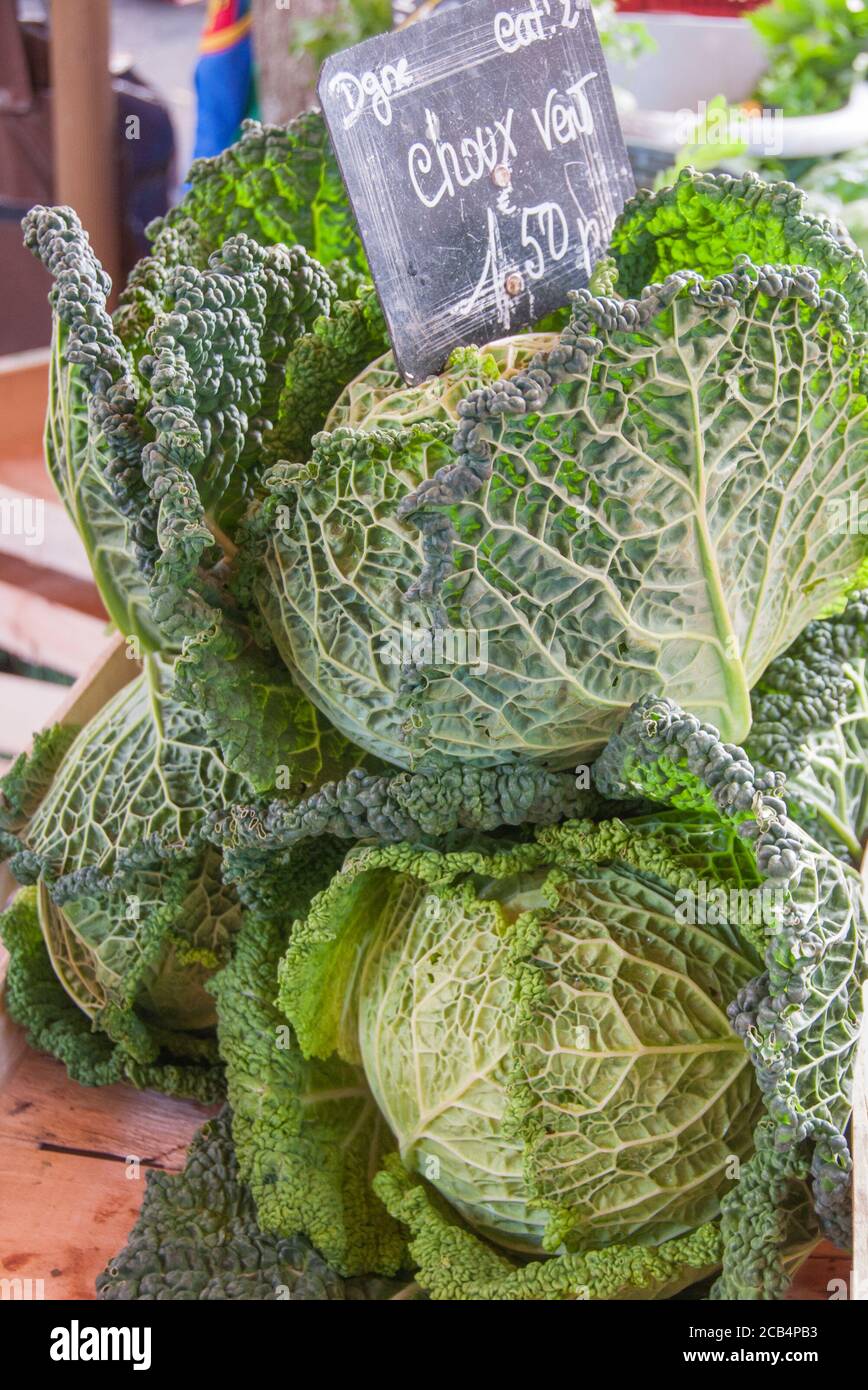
{"left": 136, "top": 236, "right": 335, "bottom": 646}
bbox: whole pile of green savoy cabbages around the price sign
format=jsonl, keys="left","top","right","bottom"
{"left": 3, "top": 115, "right": 868, "bottom": 1300}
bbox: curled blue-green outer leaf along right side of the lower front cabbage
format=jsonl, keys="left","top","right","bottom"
{"left": 594, "top": 699, "right": 868, "bottom": 1278}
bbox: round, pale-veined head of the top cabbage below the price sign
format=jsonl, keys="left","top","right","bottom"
{"left": 246, "top": 263, "right": 868, "bottom": 767}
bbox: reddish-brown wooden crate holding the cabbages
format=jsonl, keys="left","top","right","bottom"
{"left": 0, "top": 356, "right": 868, "bottom": 1300}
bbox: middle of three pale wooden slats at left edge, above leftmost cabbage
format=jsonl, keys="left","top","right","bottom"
{"left": 0, "top": 580, "right": 106, "bottom": 676}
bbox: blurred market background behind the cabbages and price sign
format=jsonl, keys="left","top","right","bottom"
{"left": 0, "top": 0, "right": 868, "bottom": 770}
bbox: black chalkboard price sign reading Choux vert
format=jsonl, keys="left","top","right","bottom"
{"left": 319, "top": 0, "right": 633, "bottom": 382}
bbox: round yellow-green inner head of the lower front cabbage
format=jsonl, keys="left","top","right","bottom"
{"left": 284, "top": 821, "right": 762, "bottom": 1251}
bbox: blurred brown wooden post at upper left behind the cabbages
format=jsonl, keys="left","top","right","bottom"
{"left": 51, "top": 0, "right": 120, "bottom": 297}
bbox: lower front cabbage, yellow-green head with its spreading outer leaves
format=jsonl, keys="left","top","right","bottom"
{"left": 268, "top": 698, "right": 865, "bottom": 1300}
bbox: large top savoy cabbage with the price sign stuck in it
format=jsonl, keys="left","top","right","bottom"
{"left": 28, "top": 156, "right": 868, "bottom": 790}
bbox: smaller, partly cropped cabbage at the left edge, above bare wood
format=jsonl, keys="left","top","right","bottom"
{"left": 0, "top": 656, "right": 245, "bottom": 1099}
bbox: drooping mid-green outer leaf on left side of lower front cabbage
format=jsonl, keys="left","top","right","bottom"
{"left": 211, "top": 867, "right": 405, "bottom": 1275}
